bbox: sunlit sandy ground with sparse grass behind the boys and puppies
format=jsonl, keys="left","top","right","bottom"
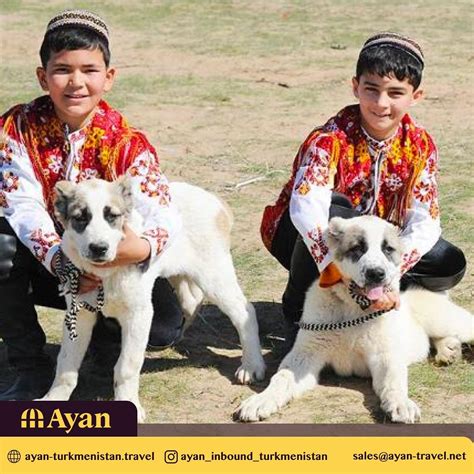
{"left": 0, "top": 0, "right": 474, "bottom": 423}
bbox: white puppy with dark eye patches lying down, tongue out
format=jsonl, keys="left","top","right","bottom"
{"left": 236, "top": 216, "right": 474, "bottom": 423}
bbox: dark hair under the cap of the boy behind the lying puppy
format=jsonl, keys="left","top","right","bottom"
{"left": 356, "top": 45, "right": 423, "bottom": 90}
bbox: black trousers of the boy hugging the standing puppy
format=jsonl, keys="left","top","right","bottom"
{"left": 0, "top": 217, "right": 180, "bottom": 371}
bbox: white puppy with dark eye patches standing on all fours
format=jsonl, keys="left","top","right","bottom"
{"left": 39, "top": 177, "right": 265, "bottom": 422}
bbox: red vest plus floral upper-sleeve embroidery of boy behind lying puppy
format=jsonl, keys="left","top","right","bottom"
{"left": 260, "top": 105, "right": 439, "bottom": 250}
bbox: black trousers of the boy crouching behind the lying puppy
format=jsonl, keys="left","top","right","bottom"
{"left": 271, "top": 197, "right": 466, "bottom": 322}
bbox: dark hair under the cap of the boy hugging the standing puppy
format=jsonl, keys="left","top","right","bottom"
{"left": 40, "top": 26, "right": 110, "bottom": 69}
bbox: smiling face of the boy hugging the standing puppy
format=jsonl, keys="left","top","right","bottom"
{"left": 36, "top": 48, "right": 115, "bottom": 130}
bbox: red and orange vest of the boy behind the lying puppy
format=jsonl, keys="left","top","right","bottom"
{"left": 260, "top": 105, "right": 438, "bottom": 250}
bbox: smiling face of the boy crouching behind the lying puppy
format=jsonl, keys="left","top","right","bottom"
{"left": 352, "top": 74, "right": 423, "bottom": 140}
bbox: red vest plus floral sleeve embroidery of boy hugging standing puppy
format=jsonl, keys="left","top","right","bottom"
{"left": 0, "top": 96, "right": 170, "bottom": 261}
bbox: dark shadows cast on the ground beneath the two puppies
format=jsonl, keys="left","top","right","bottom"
{"left": 0, "top": 302, "right": 474, "bottom": 423}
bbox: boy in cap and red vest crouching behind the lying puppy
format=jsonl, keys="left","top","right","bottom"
{"left": 261, "top": 33, "right": 466, "bottom": 343}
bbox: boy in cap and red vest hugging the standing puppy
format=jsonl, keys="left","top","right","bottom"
{"left": 0, "top": 10, "right": 183, "bottom": 400}
